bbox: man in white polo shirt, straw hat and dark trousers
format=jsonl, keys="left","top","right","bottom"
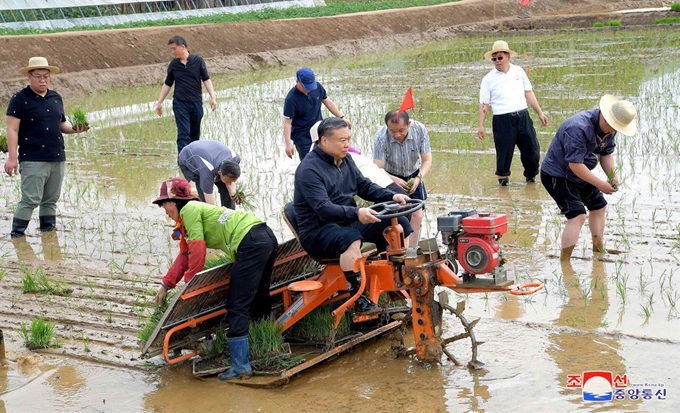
{"left": 477, "top": 40, "right": 548, "bottom": 186}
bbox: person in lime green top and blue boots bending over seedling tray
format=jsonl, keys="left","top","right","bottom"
{"left": 153, "top": 178, "right": 278, "bottom": 380}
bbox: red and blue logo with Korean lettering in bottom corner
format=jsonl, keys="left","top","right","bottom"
{"left": 567, "top": 371, "right": 666, "bottom": 402}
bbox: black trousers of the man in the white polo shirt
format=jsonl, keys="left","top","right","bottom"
{"left": 492, "top": 109, "right": 541, "bottom": 178}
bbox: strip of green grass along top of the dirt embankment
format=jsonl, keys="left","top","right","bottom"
{"left": 0, "top": 0, "right": 456, "bottom": 35}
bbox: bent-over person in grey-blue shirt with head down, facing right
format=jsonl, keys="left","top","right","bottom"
{"left": 177, "top": 140, "right": 241, "bottom": 209}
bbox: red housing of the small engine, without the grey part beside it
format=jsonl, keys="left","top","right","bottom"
{"left": 457, "top": 214, "right": 508, "bottom": 274}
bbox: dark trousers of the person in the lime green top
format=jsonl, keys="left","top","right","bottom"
{"left": 225, "top": 224, "right": 279, "bottom": 337}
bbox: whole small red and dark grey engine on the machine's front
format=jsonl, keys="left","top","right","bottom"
{"left": 437, "top": 209, "right": 508, "bottom": 281}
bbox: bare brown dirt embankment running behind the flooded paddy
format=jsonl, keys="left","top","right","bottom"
{"left": 0, "top": 0, "right": 663, "bottom": 100}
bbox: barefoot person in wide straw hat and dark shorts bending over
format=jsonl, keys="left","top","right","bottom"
{"left": 541, "top": 95, "right": 637, "bottom": 261}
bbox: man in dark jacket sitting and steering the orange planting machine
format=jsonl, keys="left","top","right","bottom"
{"left": 293, "top": 117, "right": 413, "bottom": 313}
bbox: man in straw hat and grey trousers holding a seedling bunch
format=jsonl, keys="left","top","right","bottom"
{"left": 5, "top": 57, "right": 89, "bottom": 238}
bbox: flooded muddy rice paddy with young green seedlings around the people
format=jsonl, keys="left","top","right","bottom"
{"left": 0, "top": 29, "right": 680, "bottom": 412}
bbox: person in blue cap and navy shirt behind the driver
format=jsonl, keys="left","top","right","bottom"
{"left": 283, "top": 67, "right": 352, "bottom": 160}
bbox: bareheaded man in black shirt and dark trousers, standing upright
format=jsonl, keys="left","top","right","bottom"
{"left": 156, "top": 36, "right": 217, "bottom": 154}
